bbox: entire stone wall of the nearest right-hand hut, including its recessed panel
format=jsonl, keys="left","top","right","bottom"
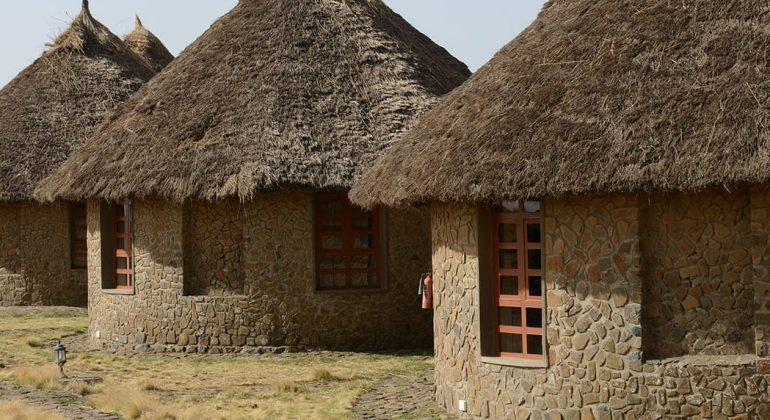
{"left": 431, "top": 190, "right": 770, "bottom": 419}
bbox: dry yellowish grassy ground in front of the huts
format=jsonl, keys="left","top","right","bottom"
{"left": 0, "top": 308, "right": 449, "bottom": 419}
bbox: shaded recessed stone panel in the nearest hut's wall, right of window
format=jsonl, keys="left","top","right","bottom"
{"left": 641, "top": 190, "right": 754, "bottom": 358}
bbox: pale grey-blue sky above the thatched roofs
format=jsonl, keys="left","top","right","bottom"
{"left": 0, "top": 0, "right": 544, "bottom": 86}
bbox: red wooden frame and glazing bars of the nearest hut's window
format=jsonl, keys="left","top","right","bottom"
{"left": 491, "top": 200, "right": 547, "bottom": 361}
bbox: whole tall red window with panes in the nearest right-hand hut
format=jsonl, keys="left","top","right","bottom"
{"left": 492, "top": 201, "right": 544, "bottom": 360}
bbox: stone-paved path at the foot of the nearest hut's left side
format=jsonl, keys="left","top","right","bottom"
{"left": 352, "top": 370, "right": 455, "bottom": 420}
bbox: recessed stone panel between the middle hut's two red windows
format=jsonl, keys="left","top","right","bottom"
{"left": 183, "top": 199, "right": 245, "bottom": 296}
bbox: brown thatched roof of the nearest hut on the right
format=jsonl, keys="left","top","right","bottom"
{"left": 352, "top": 0, "right": 770, "bottom": 206}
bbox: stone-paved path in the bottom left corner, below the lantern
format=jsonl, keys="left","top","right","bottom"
{"left": 0, "top": 382, "right": 120, "bottom": 420}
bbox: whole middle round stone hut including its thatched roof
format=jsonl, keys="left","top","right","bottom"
{"left": 38, "top": 0, "right": 469, "bottom": 353}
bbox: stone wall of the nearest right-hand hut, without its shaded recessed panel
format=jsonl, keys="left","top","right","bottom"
{"left": 431, "top": 196, "right": 770, "bottom": 419}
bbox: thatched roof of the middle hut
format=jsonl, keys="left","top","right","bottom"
{"left": 38, "top": 0, "right": 469, "bottom": 201}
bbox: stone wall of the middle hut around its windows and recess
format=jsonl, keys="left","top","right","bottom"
{"left": 88, "top": 191, "right": 433, "bottom": 353}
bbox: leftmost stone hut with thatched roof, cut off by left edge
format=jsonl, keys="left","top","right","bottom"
{"left": 0, "top": 2, "right": 168, "bottom": 306}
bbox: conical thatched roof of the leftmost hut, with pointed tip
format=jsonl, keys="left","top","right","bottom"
{"left": 0, "top": 1, "right": 154, "bottom": 201}
